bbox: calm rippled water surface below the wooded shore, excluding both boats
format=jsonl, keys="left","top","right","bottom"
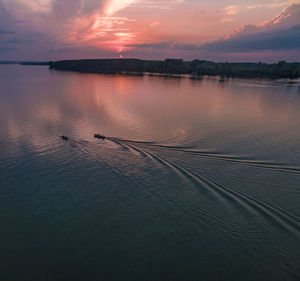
{"left": 0, "top": 66, "right": 300, "bottom": 281}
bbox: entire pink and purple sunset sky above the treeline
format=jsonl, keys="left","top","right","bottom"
{"left": 0, "top": 0, "right": 300, "bottom": 62}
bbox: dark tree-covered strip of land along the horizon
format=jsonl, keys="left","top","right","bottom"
{"left": 49, "top": 59, "right": 300, "bottom": 79}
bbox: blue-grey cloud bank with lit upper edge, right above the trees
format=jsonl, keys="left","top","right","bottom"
{"left": 131, "top": 4, "right": 300, "bottom": 59}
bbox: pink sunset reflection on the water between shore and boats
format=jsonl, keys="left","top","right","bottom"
{"left": 0, "top": 66, "right": 300, "bottom": 153}
